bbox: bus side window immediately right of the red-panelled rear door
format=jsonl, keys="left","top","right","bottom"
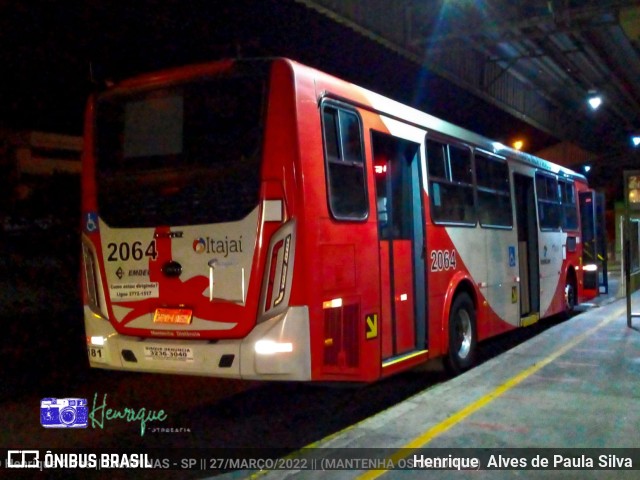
{"left": 427, "top": 139, "right": 476, "bottom": 225}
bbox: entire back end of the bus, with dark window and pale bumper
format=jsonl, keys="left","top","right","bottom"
{"left": 82, "top": 62, "right": 310, "bottom": 380}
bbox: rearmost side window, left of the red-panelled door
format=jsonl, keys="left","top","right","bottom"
{"left": 322, "top": 104, "right": 369, "bottom": 220}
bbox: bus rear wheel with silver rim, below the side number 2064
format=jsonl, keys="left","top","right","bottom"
{"left": 445, "top": 292, "right": 477, "bottom": 375}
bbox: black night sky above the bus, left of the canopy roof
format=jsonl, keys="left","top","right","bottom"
{"left": 0, "top": 0, "right": 557, "bottom": 151}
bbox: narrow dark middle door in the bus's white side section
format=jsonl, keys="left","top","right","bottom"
{"left": 513, "top": 173, "right": 540, "bottom": 326}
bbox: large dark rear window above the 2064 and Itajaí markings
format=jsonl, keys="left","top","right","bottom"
{"left": 95, "top": 69, "right": 266, "bottom": 228}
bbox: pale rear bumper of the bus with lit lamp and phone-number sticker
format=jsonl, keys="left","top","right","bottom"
{"left": 84, "top": 306, "right": 311, "bottom": 381}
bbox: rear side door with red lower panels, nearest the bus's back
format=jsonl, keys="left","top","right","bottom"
{"left": 372, "top": 132, "right": 426, "bottom": 360}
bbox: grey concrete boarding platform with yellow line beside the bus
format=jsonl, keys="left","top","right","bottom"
{"left": 216, "top": 276, "right": 640, "bottom": 479}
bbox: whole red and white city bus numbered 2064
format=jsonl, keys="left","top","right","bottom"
{"left": 82, "top": 59, "right": 597, "bottom": 382}
